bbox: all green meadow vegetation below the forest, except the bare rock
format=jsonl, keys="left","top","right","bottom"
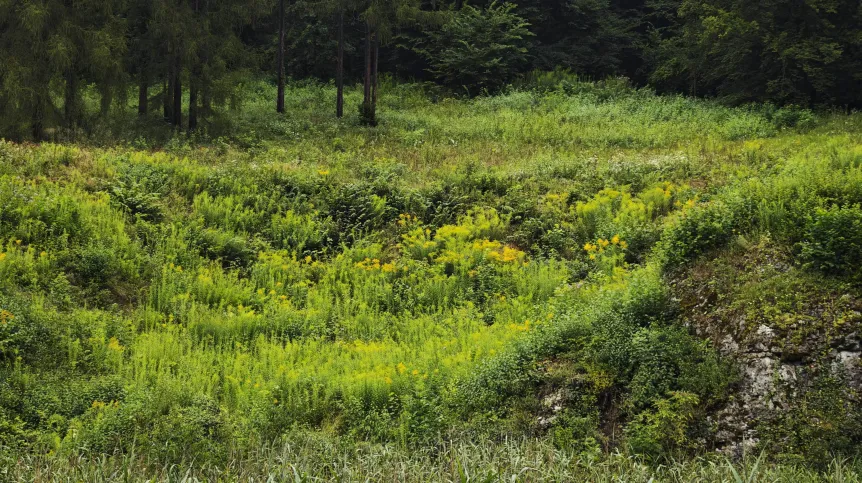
{"left": 0, "top": 77, "right": 862, "bottom": 482}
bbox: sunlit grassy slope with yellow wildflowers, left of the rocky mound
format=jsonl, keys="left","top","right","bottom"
{"left": 0, "top": 80, "right": 862, "bottom": 479}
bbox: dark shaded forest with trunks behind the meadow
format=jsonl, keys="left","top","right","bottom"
{"left": 0, "top": 0, "right": 862, "bottom": 139}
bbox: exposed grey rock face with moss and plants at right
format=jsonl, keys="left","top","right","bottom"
{"left": 672, "top": 241, "right": 862, "bottom": 454}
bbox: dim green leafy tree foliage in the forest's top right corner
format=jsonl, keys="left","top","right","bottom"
{"left": 652, "top": 0, "right": 860, "bottom": 105}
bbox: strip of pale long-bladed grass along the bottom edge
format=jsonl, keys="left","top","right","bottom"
{"left": 6, "top": 436, "right": 862, "bottom": 483}
